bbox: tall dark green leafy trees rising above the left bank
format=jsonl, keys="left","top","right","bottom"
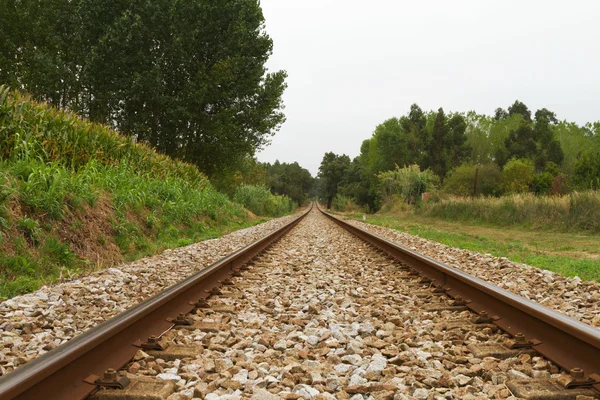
{"left": 0, "top": 0, "right": 286, "bottom": 175}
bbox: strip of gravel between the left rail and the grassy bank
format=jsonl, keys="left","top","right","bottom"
{"left": 0, "top": 211, "right": 297, "bottom": 376}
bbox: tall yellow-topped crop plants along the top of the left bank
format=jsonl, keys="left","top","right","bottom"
{"left": 0, "top": 87, "right": 209, "bottom": 187}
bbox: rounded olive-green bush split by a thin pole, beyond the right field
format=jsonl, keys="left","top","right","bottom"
{"left": 442, "top": 164, "right": 501, "bottom": 196}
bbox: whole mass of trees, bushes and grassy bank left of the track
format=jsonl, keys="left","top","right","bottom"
{"left": 0, "top": 0, "right": 314, "bottom": 299}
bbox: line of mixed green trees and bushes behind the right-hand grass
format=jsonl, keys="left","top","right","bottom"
{"left": 318, "top": 100, "right": 600, "bottom": 210}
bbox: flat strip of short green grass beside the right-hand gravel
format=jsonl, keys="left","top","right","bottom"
{"left": 342, "top": 212, "right": 600, "bottom": 281}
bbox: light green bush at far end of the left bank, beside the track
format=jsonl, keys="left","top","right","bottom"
{"left": 233, "top": 185, "right": 296, "bottom": 217}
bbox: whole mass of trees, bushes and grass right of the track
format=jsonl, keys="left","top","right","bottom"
{"left": 317, "top": 101, "right": 600, "bottom": 280}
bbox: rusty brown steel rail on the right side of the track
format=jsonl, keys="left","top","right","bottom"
{"left": 317, "top": 206, "right": 600, "bottom": 389}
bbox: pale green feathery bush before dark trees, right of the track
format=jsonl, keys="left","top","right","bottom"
{"left": 377, "top": 164, "right": 439, "bottom": 204}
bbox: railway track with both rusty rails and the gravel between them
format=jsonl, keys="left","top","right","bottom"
{"left": 0, "top": 205, "right": 600, "bottom": 400}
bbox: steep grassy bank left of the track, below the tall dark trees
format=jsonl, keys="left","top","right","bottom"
{"left": 0, "top": 87, "right": 264, "bottom": 298}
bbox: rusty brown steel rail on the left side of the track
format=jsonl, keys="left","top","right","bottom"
{"left": 0, "top": 204, "right": 312, "bottom": 400}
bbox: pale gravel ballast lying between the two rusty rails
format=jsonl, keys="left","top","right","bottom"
{"left": 117, "top": 210, "right": 580, "bottom": 400}
